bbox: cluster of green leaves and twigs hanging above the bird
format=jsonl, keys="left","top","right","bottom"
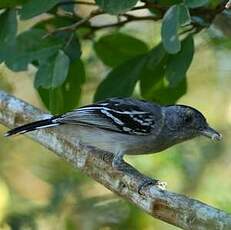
{"left": 0, "top": 0, "right": 224, "bottom": 113}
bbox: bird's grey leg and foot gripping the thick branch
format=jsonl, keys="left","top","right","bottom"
{"left": 112, "top": 152, "right": 166, "bottom": 194}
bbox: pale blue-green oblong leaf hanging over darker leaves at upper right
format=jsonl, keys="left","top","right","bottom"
{"left": 161, "top": 5, "right": 181, "bottom": 54}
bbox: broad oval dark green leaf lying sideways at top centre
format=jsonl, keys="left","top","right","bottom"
{"left": 94, "top": 33, "right": 148, "bottom": 67}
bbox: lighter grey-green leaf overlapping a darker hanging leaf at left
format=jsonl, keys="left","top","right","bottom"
{"left": 34, "top": 51, "right": 70, "bottom": 89}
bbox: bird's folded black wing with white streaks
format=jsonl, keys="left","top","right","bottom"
{"left": 56, "top": 98, "right": 161, "bottom": 135}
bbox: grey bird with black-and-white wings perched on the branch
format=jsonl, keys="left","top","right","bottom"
{"left": 5, "top": 98, "right": 222, "bottom": 168}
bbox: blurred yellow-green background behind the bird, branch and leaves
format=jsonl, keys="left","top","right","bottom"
{"left": 0, "top": 7, "right": 231, "bottom": 230}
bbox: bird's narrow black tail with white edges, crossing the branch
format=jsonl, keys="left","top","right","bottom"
{"left": 4, "top": 117, "right": 60, "bottom": 137}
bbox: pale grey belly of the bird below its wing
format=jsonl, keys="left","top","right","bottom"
{"left": 54, "top": 125, "right": 162, "bottom": 155}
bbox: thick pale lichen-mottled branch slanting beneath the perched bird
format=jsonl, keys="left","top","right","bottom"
{"left": 0, "top": 91, "right": 231, "bottom": 230}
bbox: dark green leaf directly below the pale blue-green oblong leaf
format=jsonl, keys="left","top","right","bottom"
{"left": 166, "top": 35, "right": 194, "bottom": 88}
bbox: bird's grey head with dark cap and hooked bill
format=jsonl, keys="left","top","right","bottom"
{"left": 163, "top": 105, "right": 222, "bottom": 141}
